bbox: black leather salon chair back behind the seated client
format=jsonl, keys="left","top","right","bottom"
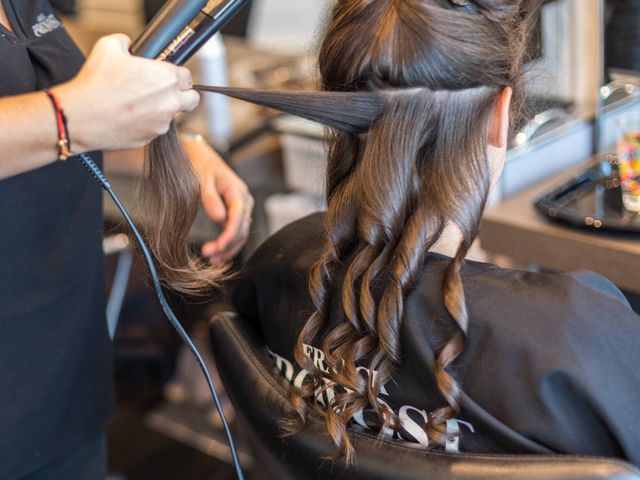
{"left": 210, "top": 313, "right": 640, "bottom": 480}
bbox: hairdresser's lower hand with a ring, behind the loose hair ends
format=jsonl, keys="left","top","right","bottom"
{"left": 185, "top": 140, "right": 254, "bottom": 265}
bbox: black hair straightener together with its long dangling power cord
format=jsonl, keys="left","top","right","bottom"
{"left": 80, "top": 0, "right": 248, "bottom": 480}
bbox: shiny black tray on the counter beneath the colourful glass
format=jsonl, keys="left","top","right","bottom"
{"left": 535, "top": 159, "right": 640, "bottom": 234}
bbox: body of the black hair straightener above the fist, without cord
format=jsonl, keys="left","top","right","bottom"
{"left": 131, "top": 0, "right": 248, "bottom": 65}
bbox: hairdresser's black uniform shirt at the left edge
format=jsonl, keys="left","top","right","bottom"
{"left": 0, "top": 0, "right": 113, "bottom": 480}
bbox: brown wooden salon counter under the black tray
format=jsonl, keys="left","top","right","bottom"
{"left": 480, "top": 159, "right": 640, "bottom": 293}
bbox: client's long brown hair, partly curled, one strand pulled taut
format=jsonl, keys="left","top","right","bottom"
{"left": 140, "top": 0, "right": 537, "bottom": 463}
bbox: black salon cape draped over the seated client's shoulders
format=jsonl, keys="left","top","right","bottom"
{"left": 232, "top": 214, "right": 640, "bottom": 465}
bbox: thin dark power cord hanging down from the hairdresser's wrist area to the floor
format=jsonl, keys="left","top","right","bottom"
{"left": 79, "top": 154, "right": 244, "bottom": 480}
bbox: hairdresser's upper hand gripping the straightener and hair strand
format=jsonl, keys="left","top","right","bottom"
{"left": 54, "top": 34, "right": 200, "bottom": 152}
